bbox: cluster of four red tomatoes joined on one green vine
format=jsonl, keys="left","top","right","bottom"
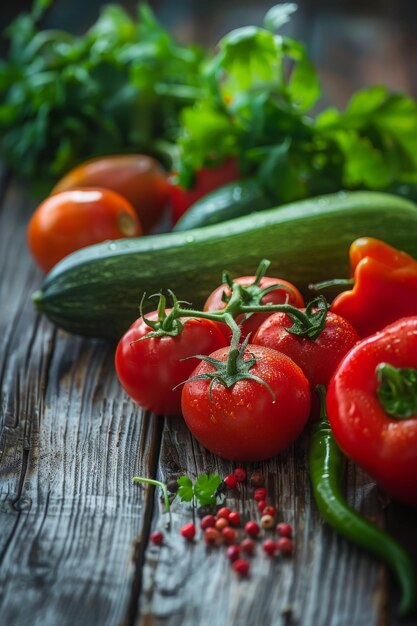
{"left": 115, "top": 266, "right": 359, "bottom": 461}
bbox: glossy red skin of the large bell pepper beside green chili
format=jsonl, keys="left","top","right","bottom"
{"left": 327, "top": 317, "right": 417, "bottom": 506}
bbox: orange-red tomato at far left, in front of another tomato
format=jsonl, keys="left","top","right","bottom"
{"left": 27, "top": 188, "right": 142, "bottom": 272}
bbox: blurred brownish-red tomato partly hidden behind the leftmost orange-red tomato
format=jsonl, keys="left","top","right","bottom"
{"left": 52, "top": 154, "right": 169, "bottom": 233}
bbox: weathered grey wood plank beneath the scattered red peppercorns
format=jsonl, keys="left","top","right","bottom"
{"left": 137, "top": 420, "right": 394, "bottom": 626}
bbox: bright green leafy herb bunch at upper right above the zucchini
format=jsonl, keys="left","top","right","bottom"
{"left": 179, "top": 3, "right": 417, "bottom": 203}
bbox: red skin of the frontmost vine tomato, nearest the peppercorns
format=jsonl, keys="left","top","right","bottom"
{"left": 181, "top": 344, "right": 310, "bottom": 461}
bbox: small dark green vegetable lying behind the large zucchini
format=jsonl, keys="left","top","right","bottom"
{"left": 173, "top": 178, "right": 274, "bottom": 231}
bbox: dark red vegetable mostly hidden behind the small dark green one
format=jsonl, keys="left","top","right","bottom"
{"left": 170, "top": 158, "right": 240, "bottom": 223}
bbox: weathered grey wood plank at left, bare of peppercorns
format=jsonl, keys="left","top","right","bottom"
{"left": 0, "top": 179, "right": 160, "bottom": 626}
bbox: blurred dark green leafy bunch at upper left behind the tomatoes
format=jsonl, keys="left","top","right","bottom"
{"left": 0, "top": 0, "right": 205, "bottom": 182}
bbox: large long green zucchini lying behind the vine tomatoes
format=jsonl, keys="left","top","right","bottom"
{"left": 33, "top": 192, "right": 417, "bottom": 339}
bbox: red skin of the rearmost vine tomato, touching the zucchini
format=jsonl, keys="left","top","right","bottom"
{"left": 203, "top": 276, "right": 304, "bottom": 340}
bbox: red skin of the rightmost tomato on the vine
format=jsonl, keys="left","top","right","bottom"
{"left": 253, "top": 312, "right": 359, "bottom": 417}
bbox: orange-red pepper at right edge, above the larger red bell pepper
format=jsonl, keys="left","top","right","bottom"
{"left": 330, "top": 237, "right": 417, "bottom": 337}
